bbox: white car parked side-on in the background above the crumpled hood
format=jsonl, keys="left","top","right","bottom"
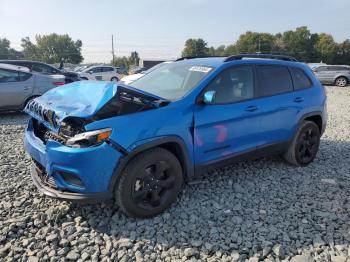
{"left": 79, "top": 65, "right": 124, "bottom": 81}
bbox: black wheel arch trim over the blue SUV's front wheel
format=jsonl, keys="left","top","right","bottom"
{"left": 108, "top": 136, "right": 194, "bottom": 193}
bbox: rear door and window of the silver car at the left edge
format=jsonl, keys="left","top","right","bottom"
{"left": 0, "top": 68, "right": 33, "bottom": 109}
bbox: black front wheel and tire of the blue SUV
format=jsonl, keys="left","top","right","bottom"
{"left": 115, "top": 147, "right": 183, "bottom": 218}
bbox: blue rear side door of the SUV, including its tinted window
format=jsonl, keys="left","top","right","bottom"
{"left": 256, "top": 65, "right": 304, "bottom": 147}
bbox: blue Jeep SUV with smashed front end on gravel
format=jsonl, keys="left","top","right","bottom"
{"left": 25, "top": 55, "right": 327, "bottom": 218}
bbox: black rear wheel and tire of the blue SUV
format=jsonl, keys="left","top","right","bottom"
{"left": 283, "top": 121, "right": 321, "bottom": 166}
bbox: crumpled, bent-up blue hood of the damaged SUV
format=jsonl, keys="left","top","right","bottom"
{"left": 24, "top": 81, "right": 167, "bottom": 131}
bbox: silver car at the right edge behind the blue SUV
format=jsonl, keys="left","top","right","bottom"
{"left": 312, "top": 65, "right": 350, "bottom": 86}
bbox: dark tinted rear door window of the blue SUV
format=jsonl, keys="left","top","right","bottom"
{"left": 257, "top": 65, "right": 293, "bottom": 97}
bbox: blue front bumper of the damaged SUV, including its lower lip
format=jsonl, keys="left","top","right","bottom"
{"left": 24, "top": 120, "right": 122, "bottom": 200}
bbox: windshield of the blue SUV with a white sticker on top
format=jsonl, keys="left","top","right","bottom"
{"left": 131, "top": 63, "right": 213, "bottom": 100}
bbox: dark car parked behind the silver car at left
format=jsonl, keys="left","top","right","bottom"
{"left": 0, "top": 60, "right": 80, "bottom": 84}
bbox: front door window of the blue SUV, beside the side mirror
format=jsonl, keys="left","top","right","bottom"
{"left": 207, "top": 66, "right": 254, "bottom": 104}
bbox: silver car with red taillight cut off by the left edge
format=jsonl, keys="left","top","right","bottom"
{"left": 0, "top": 64, "right": 65, "bottom": 111}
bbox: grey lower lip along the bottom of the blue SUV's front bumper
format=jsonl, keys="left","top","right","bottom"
{"left": 30, "top": 163, "right": 112, "bottom": 203}
